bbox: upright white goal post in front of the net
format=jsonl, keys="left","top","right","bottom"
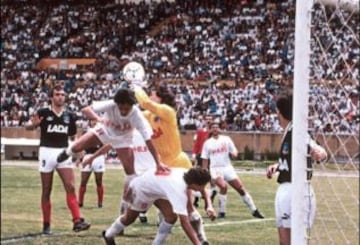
{"left": 291, "top": 0, "right": 312, "bottom": 245}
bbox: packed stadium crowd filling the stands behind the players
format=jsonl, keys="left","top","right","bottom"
{"left": 1, "top": 0, "right": 360, "bottom": 133}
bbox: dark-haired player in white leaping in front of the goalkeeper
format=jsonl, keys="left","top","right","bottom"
{"left": 57, "top": 88, "right": 167, "bottom": 176}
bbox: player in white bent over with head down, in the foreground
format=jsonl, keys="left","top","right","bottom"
{"left": 103, "top": 168, "right": 211, "bottom": 245}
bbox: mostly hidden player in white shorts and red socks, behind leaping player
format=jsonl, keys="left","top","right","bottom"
{"left": 78, "top": 120, "right": 107, "bottom": 208}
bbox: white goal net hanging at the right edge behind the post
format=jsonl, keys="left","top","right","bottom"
{"left": 292, "top": 0, "right": 360, "bottom": 245}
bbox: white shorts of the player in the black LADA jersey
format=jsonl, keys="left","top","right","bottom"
{"left": 39, "top": 146, "right": 75, "bottom": 173}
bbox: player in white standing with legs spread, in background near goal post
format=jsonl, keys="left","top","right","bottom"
{"left": 201, "top": 122, "right": 264, "bottom": 219}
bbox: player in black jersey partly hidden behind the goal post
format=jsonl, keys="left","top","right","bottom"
{"left": 266, "top": 96, "right": 327, "bottom": 245}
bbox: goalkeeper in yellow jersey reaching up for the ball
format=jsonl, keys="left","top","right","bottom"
{"left": 131, "top": 79, "right": 215, "bottom": 244}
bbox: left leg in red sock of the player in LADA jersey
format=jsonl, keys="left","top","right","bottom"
{"left": 40, "top": 172, "right": 54, "bottom": 235}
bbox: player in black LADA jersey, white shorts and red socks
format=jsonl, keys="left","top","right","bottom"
{"left": 25, "top": 85, "right": 90, "bottom": 234}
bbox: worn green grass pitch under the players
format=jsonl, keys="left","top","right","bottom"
{"left": 1, "top": 162, "right": 359, "bottom": 245}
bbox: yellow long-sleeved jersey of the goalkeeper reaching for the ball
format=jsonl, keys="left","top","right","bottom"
{"left": 135, "top": 87, "right": 192, "bottom": 168}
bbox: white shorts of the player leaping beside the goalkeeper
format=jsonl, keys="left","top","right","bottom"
{"left": 90, "top": 123, "right": 133, "bottom": 149}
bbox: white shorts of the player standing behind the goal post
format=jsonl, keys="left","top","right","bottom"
{"left": 275, "top": 182, "right": 316, "bottom": 228}
